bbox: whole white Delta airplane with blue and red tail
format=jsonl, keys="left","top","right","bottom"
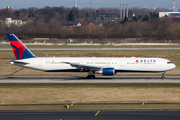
{"left": 7, "top": 33, "right": 176, "bottom": 79}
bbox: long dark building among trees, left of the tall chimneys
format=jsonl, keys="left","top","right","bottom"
{"left": 92, "top": 13, "right": 119, "bottom": 20}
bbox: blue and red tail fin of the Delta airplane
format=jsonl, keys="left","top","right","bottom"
{"left": 7, "top": 34, "right": 36, "bottom": 60}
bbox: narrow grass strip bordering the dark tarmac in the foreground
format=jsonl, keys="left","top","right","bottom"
{"left": 0, "top": 105, "right": 180, "bottom": 110}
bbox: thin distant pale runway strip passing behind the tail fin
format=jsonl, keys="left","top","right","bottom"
{"left": 0, "top": 47, "right": 180, "bottom": 50}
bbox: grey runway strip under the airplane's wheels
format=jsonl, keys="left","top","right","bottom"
{"left": 0, "top": 76, "right": 180, "bottom": 83}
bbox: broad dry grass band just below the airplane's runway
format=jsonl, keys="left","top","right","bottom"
{"left": 0, "top": 84, "right": 180, "bottom": 104}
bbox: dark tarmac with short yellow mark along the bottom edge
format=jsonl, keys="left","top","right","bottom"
{"left": 0, "top": 110, "right": 180, "bottom": 120}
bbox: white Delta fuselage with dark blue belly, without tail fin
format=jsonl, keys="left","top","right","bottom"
{"left": 11, "top": 57, "right": 176, "bottom": 72}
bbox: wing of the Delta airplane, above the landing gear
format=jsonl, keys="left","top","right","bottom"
{"left": 63, "top": 62, "right": 102, "bottom": 71}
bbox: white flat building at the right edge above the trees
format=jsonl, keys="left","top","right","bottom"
{"left": 159, "top": 12, "right": 180, "bottom": 18}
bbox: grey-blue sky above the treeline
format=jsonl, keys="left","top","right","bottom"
{"left": 0, "top": 0, "right": 180, "bottom": 9}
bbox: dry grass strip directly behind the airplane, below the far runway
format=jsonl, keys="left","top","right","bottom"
{"left": 0, "top": 50, "right": 180, "bottom": 60}
